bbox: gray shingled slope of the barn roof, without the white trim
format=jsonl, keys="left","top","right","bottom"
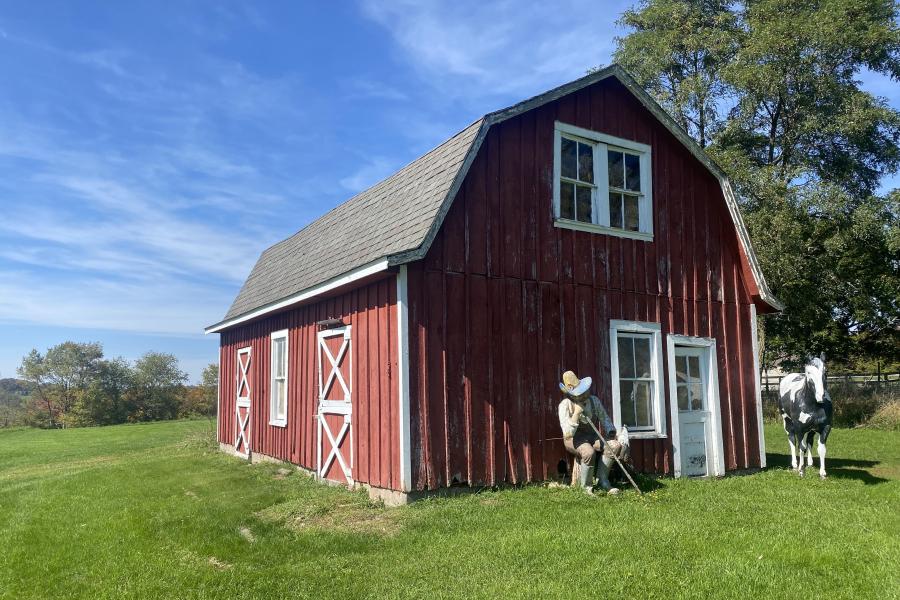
{"left": 225, "top": 119, "right": 483, "bottom": 320}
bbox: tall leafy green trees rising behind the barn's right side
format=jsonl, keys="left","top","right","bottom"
{"left": 615, "top": 0, "right": 900, "bottom": 370}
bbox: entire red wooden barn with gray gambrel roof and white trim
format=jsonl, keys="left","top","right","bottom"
{"left": 207, "top": 65, "right": 780, "bottom": 501}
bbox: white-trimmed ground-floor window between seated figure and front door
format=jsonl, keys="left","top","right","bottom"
{"left": 609, "top": 320, "right": 666, "bottom": 437}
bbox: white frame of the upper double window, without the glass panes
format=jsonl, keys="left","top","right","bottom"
{"left": 553, "top": 121, "right": 653, "bottom": 242}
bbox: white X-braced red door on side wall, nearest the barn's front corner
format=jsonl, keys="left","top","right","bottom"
{"left": 317, "top": 325, "right": 353, "bottom": 485}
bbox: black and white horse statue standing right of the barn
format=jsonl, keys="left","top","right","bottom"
{"left": 778, "top": 356, "right": 833, "bottom": 479}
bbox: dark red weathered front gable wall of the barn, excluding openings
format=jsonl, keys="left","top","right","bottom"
{"left": 409, "top": 79, "right": 759, "bottom": 489}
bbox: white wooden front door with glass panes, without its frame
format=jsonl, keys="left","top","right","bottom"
{"left": 675, "top": 346, "right": 712, "bottom": 477}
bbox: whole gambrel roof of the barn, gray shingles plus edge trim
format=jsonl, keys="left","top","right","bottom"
{"left": 206, "top": 64, "right": 783, "bottom": 333}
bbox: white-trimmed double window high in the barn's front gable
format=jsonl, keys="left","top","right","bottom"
{"left": 553, "top": 121, "right": 653, "bottom": 240}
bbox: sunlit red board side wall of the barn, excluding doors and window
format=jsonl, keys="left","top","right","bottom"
{"left": 218, "top": 276, "right": 400, "bottom": 489}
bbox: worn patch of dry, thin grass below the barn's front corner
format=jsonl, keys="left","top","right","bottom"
{"left": 256, "top": 494, "right": 403, "bottom": 537}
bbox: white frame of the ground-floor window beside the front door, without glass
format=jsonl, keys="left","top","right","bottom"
{"left": 609, "top": 319, "right": 666, "bottom": 439}
